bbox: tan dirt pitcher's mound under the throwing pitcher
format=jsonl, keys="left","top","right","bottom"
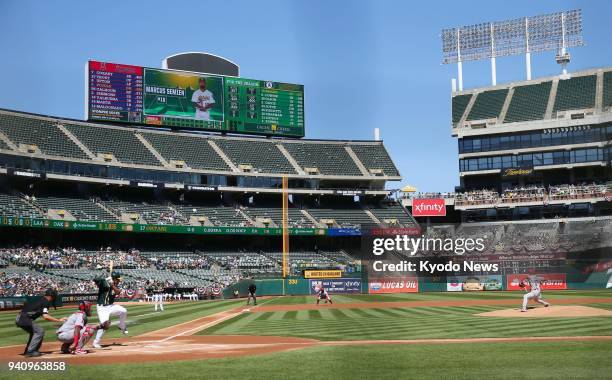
{"left": 476, "top": 306, "right": 612, "bottom": 318}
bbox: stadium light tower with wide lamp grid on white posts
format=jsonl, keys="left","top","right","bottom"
{"left": 441, "top": 9, "right": 584, "bottom": 91}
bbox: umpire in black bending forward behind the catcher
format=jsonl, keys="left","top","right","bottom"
{"left": 15, "top": 289, "right": 66, "bottom": 357}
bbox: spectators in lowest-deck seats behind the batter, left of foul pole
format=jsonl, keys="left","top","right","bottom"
{"left": 0, "top": 246, "right": 266, "bottom": 297}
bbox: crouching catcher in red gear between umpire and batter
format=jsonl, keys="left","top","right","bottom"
{"left": 57, "top": 301, "right": 99, "bottom": 355}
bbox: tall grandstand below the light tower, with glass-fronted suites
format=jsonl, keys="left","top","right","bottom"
{"left": 405, "top": 68, "right": 612, "bottom": 221}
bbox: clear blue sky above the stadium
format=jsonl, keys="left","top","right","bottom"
{"left": 0, "top": 0, "right": 612, "bottom": 191}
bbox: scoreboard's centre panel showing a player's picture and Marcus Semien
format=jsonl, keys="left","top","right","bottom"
{"left": 144, "top": 69, "right": 223, "bottom": 122}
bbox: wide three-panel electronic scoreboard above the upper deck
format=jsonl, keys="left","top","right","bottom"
{"left": 87, "top": 61, "right": 304, "bottom": 137}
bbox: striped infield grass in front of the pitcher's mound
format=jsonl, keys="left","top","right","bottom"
{"left": 201, "top": 304, "right": 612, "bottom": 340}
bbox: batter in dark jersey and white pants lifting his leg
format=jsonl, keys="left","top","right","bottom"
{"left": 93, "top": 272, "right": 128, "bottom": 348}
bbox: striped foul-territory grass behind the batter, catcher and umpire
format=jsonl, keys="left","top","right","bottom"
{"left": 0, "top": 300, "right": 242, "bottom": 346}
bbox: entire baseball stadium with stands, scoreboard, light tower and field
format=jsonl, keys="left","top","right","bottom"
{"left": 0, "top": 4, "right": 612, "bottom": 379}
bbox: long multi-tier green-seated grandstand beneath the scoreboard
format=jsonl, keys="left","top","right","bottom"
{"left": 0, "top": 104, "right": 417, "bottom": 297}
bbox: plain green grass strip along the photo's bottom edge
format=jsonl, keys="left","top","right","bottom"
{"left": 5, "top": 341, "right": 612, "bottom": 380}
